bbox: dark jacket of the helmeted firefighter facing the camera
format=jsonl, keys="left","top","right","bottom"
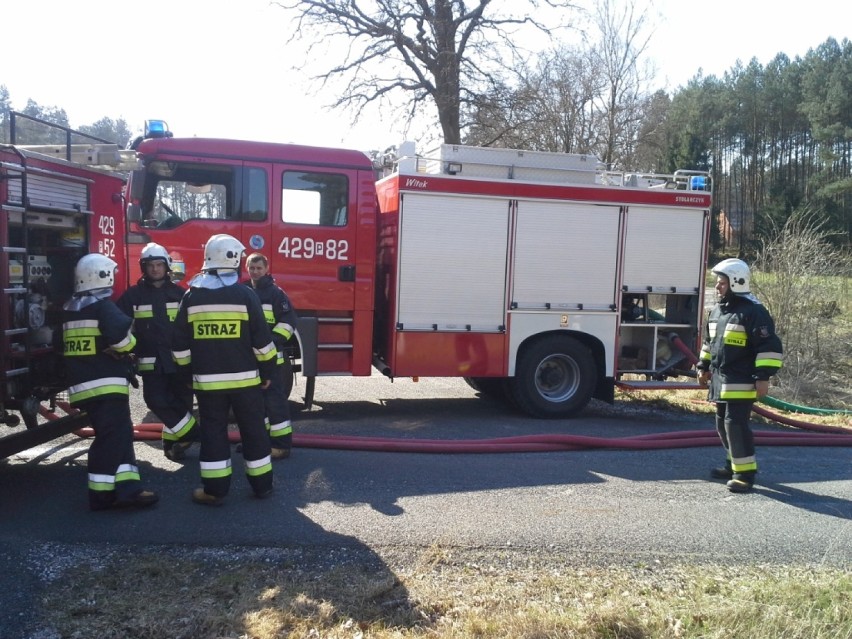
{"left": 116, "top": 277, "right": 184, "bottom": 374}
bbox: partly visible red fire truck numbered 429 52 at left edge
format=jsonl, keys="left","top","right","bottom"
{"left": 0, "top": 112, "right": 135, "bottom": 459}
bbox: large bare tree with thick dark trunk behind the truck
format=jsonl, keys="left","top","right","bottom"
{"left": 277, "top": 0, "right": 574, "bottom": 144}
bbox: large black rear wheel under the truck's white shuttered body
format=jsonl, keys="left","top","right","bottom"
{"left": 508, "top": 335, "right": 597, "bottom": 418}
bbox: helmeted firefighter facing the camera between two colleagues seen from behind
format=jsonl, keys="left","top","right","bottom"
{"left": 117, "top": 242, "right": 196, "bottom": 461}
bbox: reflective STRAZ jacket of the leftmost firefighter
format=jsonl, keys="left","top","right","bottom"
{"left": 62, "top": 296, "right": 136, "bottom": 406}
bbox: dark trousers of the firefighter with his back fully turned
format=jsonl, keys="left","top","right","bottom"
{"left": 197, "top": 386, "right": 272, "bottom": 497}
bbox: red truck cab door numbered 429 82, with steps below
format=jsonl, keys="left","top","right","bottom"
{"left": 269, "top": 163, "right": 375, "bottom": 376}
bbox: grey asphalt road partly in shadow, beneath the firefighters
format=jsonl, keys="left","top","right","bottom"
{"left": 0, "top": 377, "right": 852, "bottom": 637}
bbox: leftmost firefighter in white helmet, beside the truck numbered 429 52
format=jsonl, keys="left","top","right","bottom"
{"left": 62, "top": 253, "right": 159, "bottom": 510}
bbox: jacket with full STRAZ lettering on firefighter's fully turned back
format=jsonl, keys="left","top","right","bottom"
{"left": 172, "top": 276, "right": 277, "bottom": 392}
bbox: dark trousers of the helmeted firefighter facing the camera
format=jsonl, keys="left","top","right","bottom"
{"left": 142, "top": 373, "right": 196, "bottom": 450}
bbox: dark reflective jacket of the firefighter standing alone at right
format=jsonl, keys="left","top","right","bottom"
{"left": 697, "top": 294, "right": 782, "bottom": 401}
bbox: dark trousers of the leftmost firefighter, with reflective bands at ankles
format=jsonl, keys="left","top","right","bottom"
{"left": 85, "top": 396, "right": 142, "bottom": 509}
